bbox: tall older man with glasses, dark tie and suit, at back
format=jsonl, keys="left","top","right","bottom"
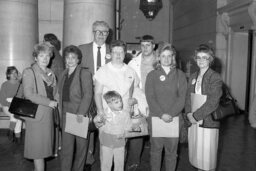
{"left": 79, "top": 21, "right": 111, "bottom": 170}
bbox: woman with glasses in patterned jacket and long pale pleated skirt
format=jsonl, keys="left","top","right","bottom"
{"left": 185, "top": 45, "right": 222, "bottom": 171}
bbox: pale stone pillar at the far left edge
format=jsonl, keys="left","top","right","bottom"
{"left": 0, "top": 0, "right": 38, "bottom": 83}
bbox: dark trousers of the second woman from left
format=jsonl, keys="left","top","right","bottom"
{"left": 61, "top": 103, "right": 90, "bottom": 171}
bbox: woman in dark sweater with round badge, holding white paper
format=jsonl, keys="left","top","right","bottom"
{"left": 145, "top": 43, "right": 187, "bottom": 171}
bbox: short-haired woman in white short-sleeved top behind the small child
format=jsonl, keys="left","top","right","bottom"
{"left": 94, "top": 40, "right": 139, "bottom": 169}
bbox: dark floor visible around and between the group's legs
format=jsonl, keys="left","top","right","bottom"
{"left": 0, "top": 115, "right": 256, "bottom": 171}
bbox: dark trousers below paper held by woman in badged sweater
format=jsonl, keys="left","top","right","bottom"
{"left": 150, "top": 137, "right": 179, "bottom": 171}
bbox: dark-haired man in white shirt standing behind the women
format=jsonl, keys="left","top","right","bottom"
{"left": 127, "top": 35, "right": 156, "bottom": 171}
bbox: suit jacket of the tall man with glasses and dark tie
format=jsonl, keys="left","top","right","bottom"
{"left": 79, "top": 42, "right": 111, "bottom": 74}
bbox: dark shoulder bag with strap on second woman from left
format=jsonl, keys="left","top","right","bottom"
{"left": 79, "top": 68, "right": 97, "bottom": 132}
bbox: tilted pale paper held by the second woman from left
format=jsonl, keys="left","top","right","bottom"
{"left": 65, "top": 112, "right": 89, "bottom": 138}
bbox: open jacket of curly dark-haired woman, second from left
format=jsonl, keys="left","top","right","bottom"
{"left": 58, "top": 65, "right": 93, "bottom": 115}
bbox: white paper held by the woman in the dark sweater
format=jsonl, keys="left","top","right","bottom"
{"left": 152, "top": 117, "right": 179, "bottom": 138}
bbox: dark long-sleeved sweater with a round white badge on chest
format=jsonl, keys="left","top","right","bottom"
{"left": 145, "top": 67, "right": 187, "bottom": 117}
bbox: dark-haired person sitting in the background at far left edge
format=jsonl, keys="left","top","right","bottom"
{"left": 0, "top": 66, "right": 22, "bottom": 143}
